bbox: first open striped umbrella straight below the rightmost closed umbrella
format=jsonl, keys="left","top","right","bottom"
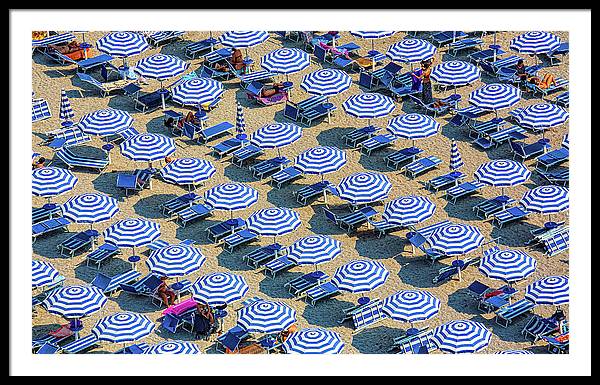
{"left": 429, "top": 223, "right": 484, "bottom": 255}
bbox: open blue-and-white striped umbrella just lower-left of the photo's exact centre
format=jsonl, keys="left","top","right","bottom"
{"left": 246, "top": 207, "right": 302, "bottom": 237}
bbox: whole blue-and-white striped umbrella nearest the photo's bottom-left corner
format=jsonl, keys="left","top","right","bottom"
{"left": 43, "top": 285, "right": 108, "bottom": 318}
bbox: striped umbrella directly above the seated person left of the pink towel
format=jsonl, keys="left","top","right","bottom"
{"left": 146, "top": 245, "right": 206, "bottom": 277}
